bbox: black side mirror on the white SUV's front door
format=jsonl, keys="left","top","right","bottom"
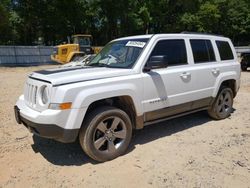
{"left": 144, "top": 55, "right": 168, "bottom": 72}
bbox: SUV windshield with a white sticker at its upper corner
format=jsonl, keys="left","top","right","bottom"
{"left": 88, "top": 38, "right": 148, "bottom": 68}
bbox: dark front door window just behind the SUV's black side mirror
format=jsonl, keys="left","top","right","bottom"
{"left": 151, "top": 39, "right": 187, "bottom": 66}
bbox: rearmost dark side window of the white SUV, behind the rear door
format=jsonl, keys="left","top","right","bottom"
{"left": 216, "top": 40, "right": 234, "bottom": 61}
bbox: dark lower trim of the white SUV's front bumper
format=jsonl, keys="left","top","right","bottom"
{"left": 14, "top": 106, "right": 79, "bottom": 143}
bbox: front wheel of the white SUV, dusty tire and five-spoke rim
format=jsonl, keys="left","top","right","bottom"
{"left": 79, "top": 106, "right": 132, "bottom": 162}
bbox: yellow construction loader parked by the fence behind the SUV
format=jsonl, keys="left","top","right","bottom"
{"left": 51, "top": 34, "right": 101, "bottom": 64}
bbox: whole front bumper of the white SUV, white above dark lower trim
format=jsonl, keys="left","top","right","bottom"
{"left": 14, "top": 95, "right": 87, "bottom": 143}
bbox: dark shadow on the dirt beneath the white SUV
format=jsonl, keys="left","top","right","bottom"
{"left": 32, "top": 112, "right": 219, "bottom": 166}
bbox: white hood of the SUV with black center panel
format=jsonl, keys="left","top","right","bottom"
{"left": 29, "top": 66, "right": 135, "bottom": 86}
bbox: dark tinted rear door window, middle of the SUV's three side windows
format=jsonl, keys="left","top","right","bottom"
{"left": 190, "top": 39, "right": 215, "bottom": 63}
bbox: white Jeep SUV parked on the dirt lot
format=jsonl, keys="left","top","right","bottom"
{"left": 15, "top": 33, "right": 240, "bottom": 161}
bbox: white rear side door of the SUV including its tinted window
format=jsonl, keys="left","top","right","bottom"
{"left": 189, "top": 38, "right": 221, "bottom": 103}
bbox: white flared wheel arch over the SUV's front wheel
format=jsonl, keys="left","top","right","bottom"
{"left": 69, "top": 83, "right": 143, "bottom": 129}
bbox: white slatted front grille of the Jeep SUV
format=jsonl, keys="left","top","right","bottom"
{"left": 24, "top": 83, "right": 37, "bottom": 107}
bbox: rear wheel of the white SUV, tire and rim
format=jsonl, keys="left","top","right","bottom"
{"left": 208, "top": 87, "right": 233, "bottom": 120}
